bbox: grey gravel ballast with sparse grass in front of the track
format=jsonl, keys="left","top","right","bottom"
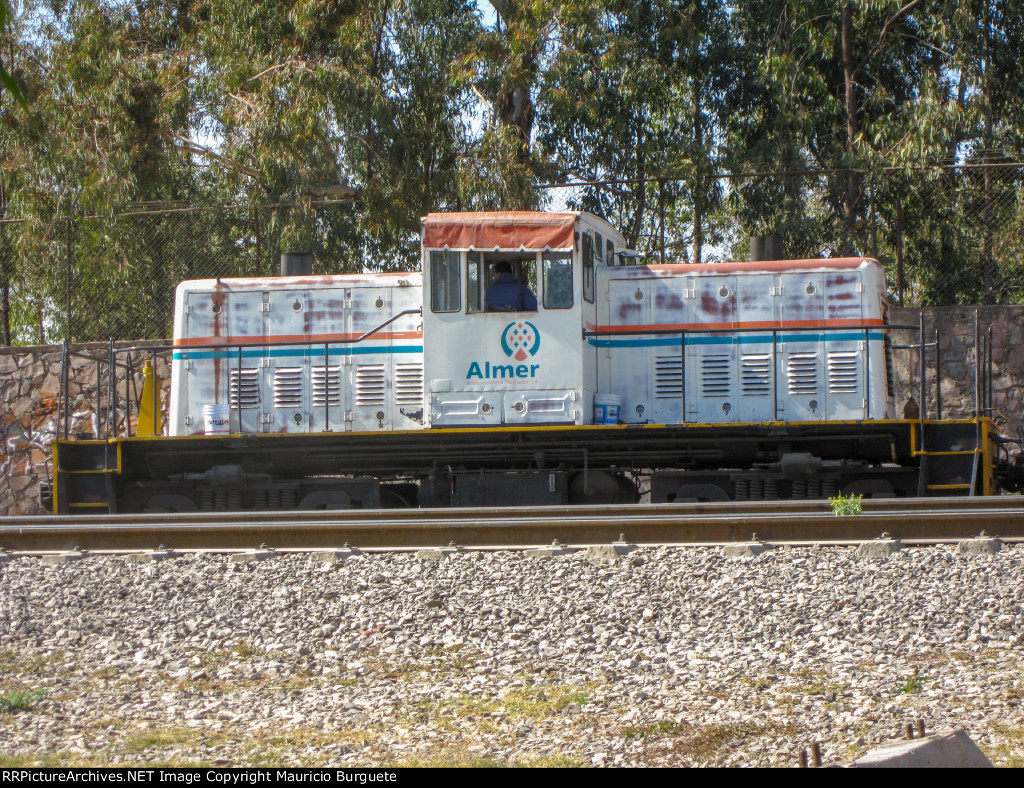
{"left": 0, "top": 546, "right": 1024, "bottom": 767}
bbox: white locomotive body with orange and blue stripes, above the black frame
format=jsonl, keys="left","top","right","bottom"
{"left": 170, "top": 212, "right": 895, "bottom": 435}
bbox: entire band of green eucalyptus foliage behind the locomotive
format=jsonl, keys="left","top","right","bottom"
{"left": 0, "top": 0, "right": 1024, "bottom": 344}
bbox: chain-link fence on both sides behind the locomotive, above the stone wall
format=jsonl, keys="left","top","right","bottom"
{"left": 0, "top": 164, "right": 1024, "bottom": 345}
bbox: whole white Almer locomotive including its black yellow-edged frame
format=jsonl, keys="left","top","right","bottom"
{"left": 54, "top": 212, "right": 1001, "bottom": 513}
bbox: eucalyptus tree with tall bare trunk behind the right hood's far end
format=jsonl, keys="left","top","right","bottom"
{"left": 730, "top": 0, "right": 937, "bottom": 253}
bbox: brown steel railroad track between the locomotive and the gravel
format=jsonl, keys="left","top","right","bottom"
{"left": 0, "top": 496, "right": 1024, "bottom": 554}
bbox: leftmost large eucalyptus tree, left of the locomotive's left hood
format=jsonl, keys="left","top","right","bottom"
{"left": 9, "top": 0, "right": 204, "bottom": 340}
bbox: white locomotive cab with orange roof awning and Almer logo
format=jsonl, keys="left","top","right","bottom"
{"left": 423, "top": 211, "right": 625, "bottom": 427}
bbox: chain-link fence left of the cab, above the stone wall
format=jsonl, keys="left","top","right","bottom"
{"left": 0, "top": 203, "right": 364, "bottom": 345}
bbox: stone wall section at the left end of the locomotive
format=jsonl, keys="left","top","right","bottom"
{"left": 0, "top": 342, "right": 169, "bottom": 515}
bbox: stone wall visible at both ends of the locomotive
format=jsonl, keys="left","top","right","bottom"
{"left": 0, "top": 306, "right": 1024, "bottom": 515}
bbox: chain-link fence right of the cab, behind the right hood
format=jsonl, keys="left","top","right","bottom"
{"left": 542, "top": 163, "right": 1024, "bottom": 307}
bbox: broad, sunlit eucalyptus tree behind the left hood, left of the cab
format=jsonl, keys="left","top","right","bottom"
{"left": 198, "top": 0, "right": 474, "bottom": 270}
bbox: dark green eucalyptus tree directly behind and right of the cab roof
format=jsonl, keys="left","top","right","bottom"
{"left": 540, "top": 0, "right": 736, "bottom": 262}
